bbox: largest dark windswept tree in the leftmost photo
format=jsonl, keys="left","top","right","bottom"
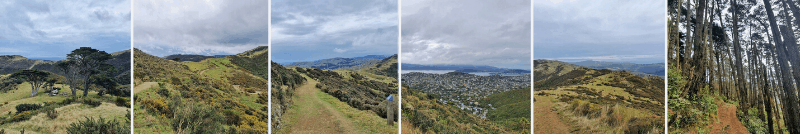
{"left": 67, "top": 47, "right": 116, "bottom": 96}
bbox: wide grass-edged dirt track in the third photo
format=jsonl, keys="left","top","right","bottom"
{"left": 285, "top": 76, "right": 356, "bottom": 134}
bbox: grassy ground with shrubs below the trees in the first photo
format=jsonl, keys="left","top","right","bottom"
{"left": 0, "top": 82, "right": 130, "bottom": 134}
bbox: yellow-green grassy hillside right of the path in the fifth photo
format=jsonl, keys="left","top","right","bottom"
{"left": 534, "top": 60, "right": 664, "bottom": 133}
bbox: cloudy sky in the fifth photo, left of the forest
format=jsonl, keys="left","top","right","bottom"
{"left": 533, "top": 0, "right": 666, "bottom": 63}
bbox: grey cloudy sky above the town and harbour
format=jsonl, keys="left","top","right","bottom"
{"left": 401, "top": 0, "right": 531, "bottom": 69}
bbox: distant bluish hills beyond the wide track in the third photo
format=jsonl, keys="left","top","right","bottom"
{"left": 285, "top": 55, "right": 387, "bottom": 70}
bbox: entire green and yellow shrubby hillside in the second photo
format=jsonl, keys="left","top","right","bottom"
{"left": 134, "top": 49, "right": 269, "bottom": 133}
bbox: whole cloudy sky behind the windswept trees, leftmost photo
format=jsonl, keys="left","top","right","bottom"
{"left": 0, "top": 0, "right": 131, "bottom": 60}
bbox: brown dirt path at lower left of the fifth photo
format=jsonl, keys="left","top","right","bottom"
{"left": 533, "top": 95, "right": 569, "bottom": 134}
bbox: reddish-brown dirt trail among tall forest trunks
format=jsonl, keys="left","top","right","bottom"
{"left": 710, "top": 103, "right": 750, "bottom": 134}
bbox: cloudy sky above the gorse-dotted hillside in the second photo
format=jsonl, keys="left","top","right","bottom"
{"left": 133, "top": 0, "right": 269, "bottom": 56}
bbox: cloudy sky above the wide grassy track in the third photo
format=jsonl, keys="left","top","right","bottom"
{"left": 271, "top": 0, "right": 399, "bottom": 63}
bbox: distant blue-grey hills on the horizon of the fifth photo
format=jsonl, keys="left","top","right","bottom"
{"left": 570, "top": 60, "right": 665, "bottom": 78}
